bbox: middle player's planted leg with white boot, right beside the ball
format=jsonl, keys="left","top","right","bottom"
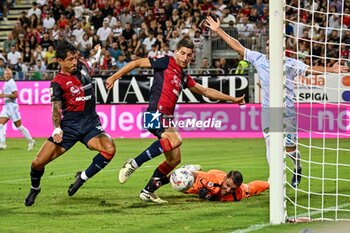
{"left": 140, "top": 147, "right": 181, "bottom": 204}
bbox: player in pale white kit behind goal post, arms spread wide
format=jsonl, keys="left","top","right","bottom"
{"left": 206, "top": 16, "right": 348, "bottom": 187}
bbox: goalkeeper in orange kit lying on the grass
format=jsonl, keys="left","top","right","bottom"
{"left": 185, "top": 165, "right": 269, "bottom": 201}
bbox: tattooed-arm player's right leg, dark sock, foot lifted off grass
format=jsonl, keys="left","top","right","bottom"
{"left": 68, "top": 133, "right": 115, "bottom": 196}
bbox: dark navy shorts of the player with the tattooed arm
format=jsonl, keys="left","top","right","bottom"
{"left": 48, "top": 114, "right": 105, "bottom": 150}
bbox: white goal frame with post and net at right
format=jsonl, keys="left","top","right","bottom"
{"left": 269, "top": 0, "right": 350, "bottom": 224}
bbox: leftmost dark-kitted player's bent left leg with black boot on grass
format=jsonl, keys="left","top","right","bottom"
{"left": 24, "top": 141, "right": 65, "bottom": 206}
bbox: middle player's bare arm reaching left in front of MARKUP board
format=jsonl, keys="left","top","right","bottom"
{"left": 105, "top": 58, "right": 152, "bottom": 90}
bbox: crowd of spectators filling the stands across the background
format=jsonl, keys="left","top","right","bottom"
{"left": 0, "top": 0, "right": 350, "bottom": 79}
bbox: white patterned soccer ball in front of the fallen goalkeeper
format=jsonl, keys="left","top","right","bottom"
{"left": 170, "top": 168, "right": 194, "bottom": 192}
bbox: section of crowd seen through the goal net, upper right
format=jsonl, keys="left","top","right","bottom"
{"left": 285, "top": 0, "right": 350, "bottom": 66}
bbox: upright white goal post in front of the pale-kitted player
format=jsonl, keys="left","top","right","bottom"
{"left": 269, "top": 0, "right": 286, "bottom": 224}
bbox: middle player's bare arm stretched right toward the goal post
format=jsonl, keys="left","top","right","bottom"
{"left": 189, "top": 83, "right": 245, "bottom": 105}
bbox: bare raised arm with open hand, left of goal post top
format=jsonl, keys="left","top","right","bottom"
{"left": 205, "top": 16, "right": 245, "bottom": 56}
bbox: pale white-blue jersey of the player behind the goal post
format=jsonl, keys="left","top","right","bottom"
{"left": 244, "top": 49, "right": 308, "bottom": 115}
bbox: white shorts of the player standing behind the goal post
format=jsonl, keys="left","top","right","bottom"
{"left": 261, "top": 108, "right": 298, "bottom": 147}
